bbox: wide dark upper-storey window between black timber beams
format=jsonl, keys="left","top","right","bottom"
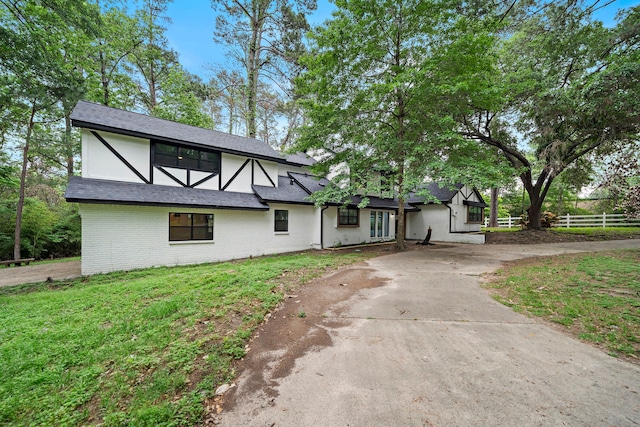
{"left": 154, "top": 142, "right": 220, "bottom": 173}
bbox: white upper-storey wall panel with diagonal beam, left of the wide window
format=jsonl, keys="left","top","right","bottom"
{"left": 82, "top": 129, "right": 150, "bottom": 182}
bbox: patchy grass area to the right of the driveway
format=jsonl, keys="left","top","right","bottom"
{"left": 486, "top": 249, "right": 640, "bottom": 363}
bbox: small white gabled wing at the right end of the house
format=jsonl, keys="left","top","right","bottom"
{"left": 406, "top": 182, "right": 488, "bottom": 244}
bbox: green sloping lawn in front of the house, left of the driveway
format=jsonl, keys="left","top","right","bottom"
{"left": 0, "top": 252, "right": 373, "bottom": 426}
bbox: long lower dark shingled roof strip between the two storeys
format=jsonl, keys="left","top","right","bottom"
{"left": 64, "top": 176, "right": 269, "bottom": 210}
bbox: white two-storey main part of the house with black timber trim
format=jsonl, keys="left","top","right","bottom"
{"left": 65, "top": 101, "right": 402, "bottom": 275}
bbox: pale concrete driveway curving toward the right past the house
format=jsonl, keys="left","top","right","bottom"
{"left": 220, "top": 240, "right": 640, "bottom": 426}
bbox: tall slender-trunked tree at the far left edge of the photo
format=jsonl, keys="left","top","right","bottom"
{"left": 0, "top": 0, "right": 98, "bottom": 259}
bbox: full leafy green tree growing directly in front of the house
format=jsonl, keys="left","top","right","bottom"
{"left": 297, "top": 0, "right": 510, "bottom": 248}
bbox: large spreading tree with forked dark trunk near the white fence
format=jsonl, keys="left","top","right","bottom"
{"left": 461, "top": 0, "right": 640, "bottom": 229}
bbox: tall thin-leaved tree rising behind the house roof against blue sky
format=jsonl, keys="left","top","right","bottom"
{"left": 212, "top": 0, "right": 316, "bottom": 138}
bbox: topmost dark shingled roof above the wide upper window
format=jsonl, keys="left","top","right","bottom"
{"left": 71, "top": 101, "right": 286, "bottom": 163}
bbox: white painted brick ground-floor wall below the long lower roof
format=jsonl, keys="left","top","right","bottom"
{"left": 80, "top": 204, "right": 316, "bottom": 275}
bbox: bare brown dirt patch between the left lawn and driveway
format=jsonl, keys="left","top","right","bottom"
{"left": 205, "top": 263, "right": 385, "bottom": 424}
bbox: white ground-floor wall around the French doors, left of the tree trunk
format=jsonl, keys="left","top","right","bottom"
{"left": 323, "top": 206, "right": 396, "bottom": 247}
